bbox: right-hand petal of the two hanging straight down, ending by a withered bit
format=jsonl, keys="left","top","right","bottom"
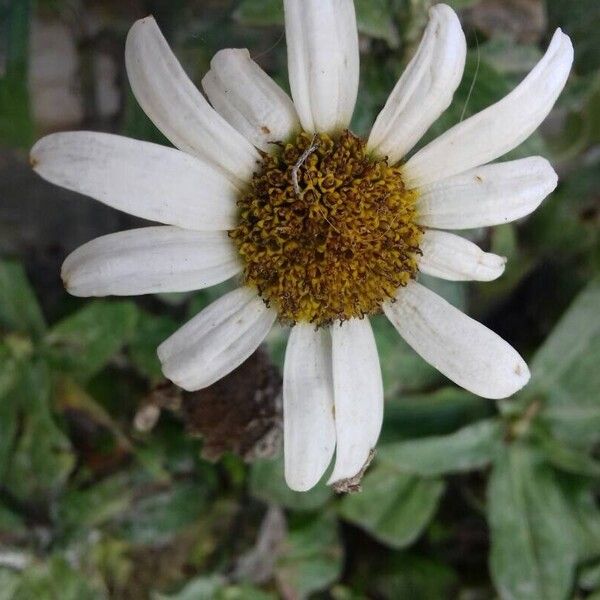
{"left": 329, "top": 319, "right": 383, "bottom": 483}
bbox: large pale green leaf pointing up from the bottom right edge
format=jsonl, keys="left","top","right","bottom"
{"left": 487, "top": 444, "right": 577, "bottom": 600}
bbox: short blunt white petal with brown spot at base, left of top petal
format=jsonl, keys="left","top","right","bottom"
{"left": 202, "top": 50, "right": 300, "bottom": 152}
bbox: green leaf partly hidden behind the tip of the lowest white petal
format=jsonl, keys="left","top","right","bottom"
{"left": 250, "top": 457, "right": 332, "bottom": 510}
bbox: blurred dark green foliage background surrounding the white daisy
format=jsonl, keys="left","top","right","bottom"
{"left": 0, "top": 0, "right": 600, "bottom": 600}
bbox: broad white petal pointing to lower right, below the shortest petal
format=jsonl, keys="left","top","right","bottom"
{"left": 383, "top": 281, "right": 529, "bottom": 399}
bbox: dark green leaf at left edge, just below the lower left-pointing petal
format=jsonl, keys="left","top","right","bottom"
{"left": 0, "top": 260, "right": 46, "bottom": 337}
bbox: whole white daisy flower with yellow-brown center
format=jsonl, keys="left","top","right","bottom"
{"left": 31, "top": 0, "right": 573, "bottom": 490}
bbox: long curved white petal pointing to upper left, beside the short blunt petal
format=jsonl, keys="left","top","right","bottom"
{"left": 125, "top": 17, "right": 259, "bottom": 181}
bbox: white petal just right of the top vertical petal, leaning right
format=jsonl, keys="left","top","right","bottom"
{"left": 368, "top": 4, "right": 467, "bottom": 164}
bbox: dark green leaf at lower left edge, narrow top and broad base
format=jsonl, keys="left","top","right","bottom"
{"left": 3, "top": 361, "right": 75, "bottom": 499}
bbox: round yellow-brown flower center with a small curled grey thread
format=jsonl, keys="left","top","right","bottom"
{"left": 229, "top": 131, "right": 423, "bottom": 326}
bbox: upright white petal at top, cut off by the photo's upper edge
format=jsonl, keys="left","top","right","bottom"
{"left": 283, "top": 0, "right": 359, "bottom": 132}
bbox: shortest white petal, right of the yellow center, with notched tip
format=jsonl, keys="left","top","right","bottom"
{"left": 419, "top": 230, "right": 506, "bottom": 281}
